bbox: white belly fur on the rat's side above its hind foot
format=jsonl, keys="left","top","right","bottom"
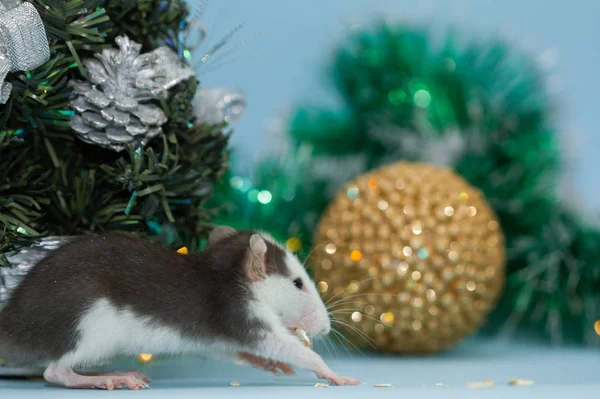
{"left": 58, "top": 299, "right": 231, "bottom": 367}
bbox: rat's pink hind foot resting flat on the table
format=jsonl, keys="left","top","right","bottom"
{"left": 44, "top": 363, "right": 148, "bottom": 391}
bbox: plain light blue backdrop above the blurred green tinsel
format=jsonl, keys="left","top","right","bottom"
{"left": 189, "top": 0, "right": 600, "bottom": 211}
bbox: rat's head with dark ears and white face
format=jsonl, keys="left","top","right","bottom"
{"left": 210, "top": 226, "right": 331, "bottom": 337}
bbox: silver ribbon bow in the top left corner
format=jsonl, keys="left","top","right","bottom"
{"left": 0, "top": 0, "right": 50, "bottom": 104}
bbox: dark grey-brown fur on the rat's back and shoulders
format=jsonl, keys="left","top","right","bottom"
{"left": 0, "top": 231, "right": 289, "bottom": 363}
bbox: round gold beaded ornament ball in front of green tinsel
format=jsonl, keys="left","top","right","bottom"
{"left": 311, "top": 162, "right": 505, "bottom": 353}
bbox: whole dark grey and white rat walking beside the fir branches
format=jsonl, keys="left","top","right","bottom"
{"left": 0, "top": 226, "right": 358, "bottom": 390}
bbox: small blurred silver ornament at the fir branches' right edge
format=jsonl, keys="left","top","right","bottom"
{"left": 192, "top": 88, "right": 246, "bottom": 124}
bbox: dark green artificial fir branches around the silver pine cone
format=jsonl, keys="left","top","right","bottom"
{"left": 0, "top": 0, "right": 229, "bottom": 266}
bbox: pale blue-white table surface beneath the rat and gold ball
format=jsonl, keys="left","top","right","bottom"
{"left": 0, "top": 339, "right": 600, "bottom": 399}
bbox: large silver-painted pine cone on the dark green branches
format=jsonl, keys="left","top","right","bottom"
{"left": 71, "top": 36, "right": 195, "bottom": 151}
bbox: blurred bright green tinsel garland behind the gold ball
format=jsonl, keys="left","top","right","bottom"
{"left": 215, "top": 24, "right": 600, "bottom": 345}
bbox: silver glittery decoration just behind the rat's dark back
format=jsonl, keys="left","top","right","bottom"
{"left": 0, "top": 236, "right": 74, "bottom": 308}
